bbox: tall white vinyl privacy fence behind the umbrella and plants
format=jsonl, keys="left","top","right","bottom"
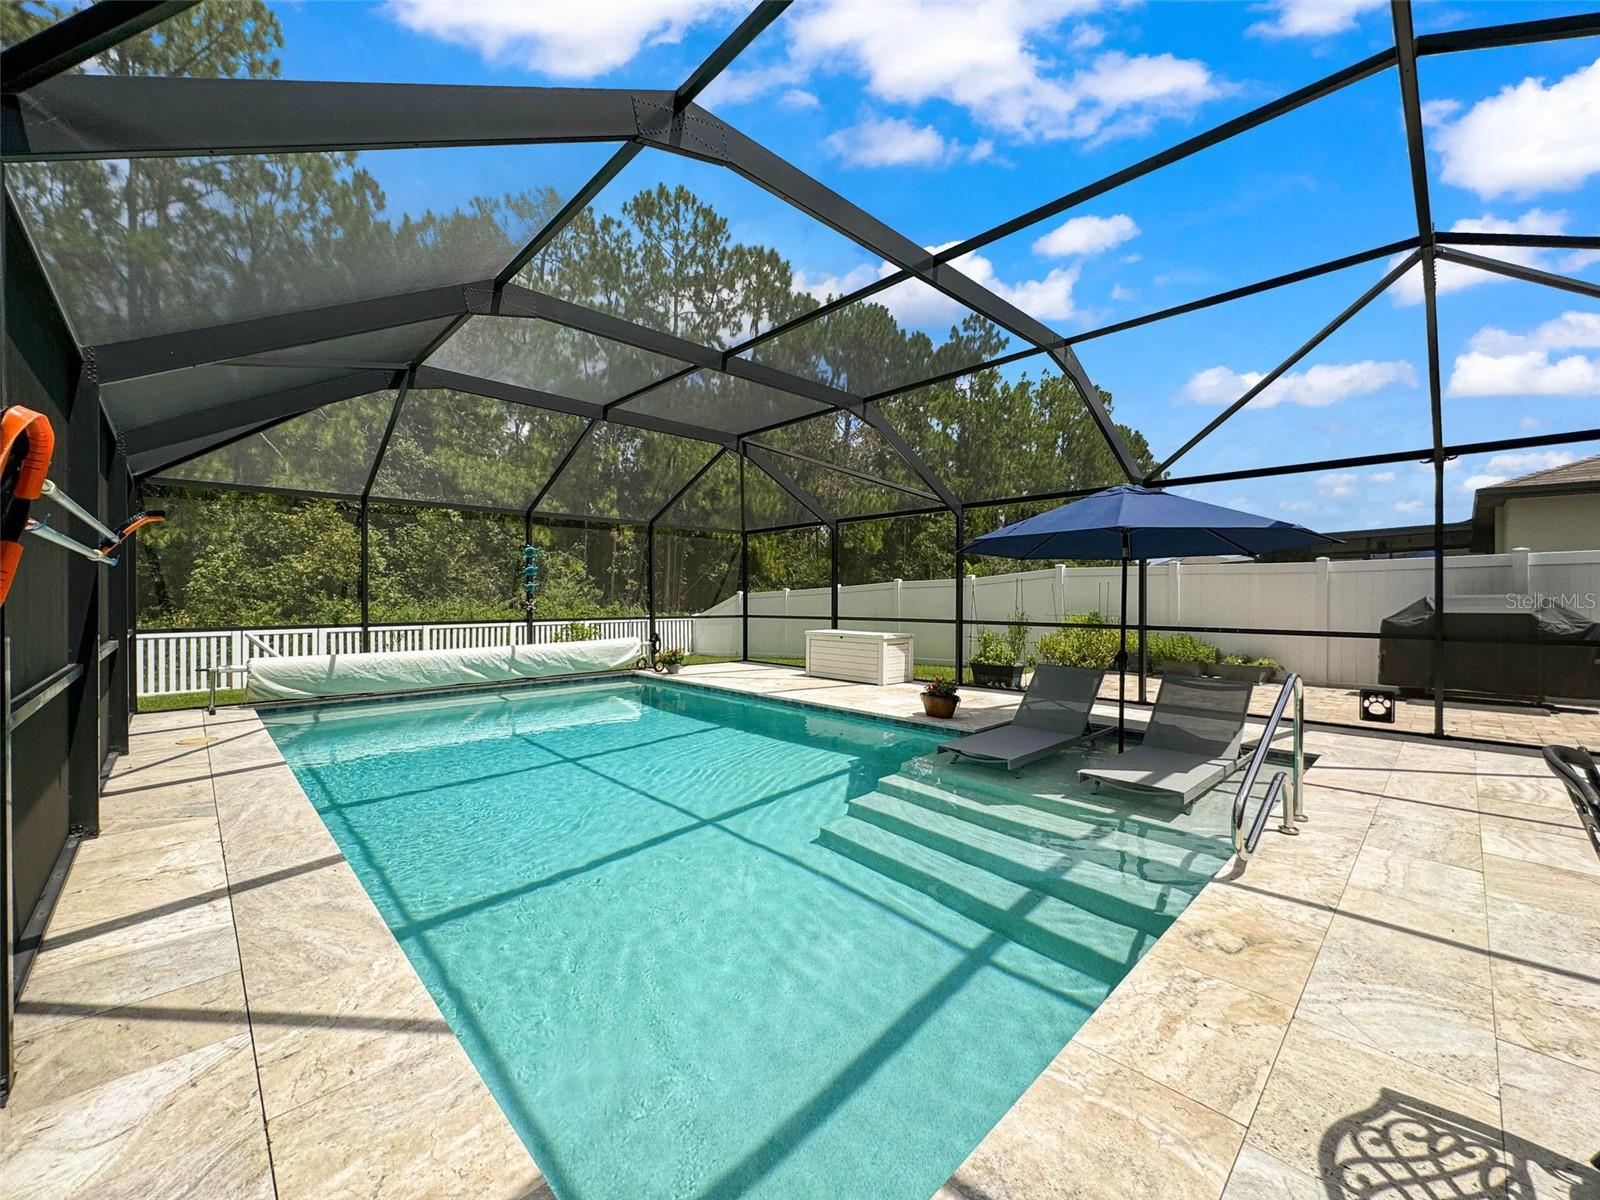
{"left": 694, "top": 550, "right": 1600, "bottom": 686}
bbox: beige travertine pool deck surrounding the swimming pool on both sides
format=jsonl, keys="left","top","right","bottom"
{"left": 0, "top": 666, "right": 1600, "bottom": 1200}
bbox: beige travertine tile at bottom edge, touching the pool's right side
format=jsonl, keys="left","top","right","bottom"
{"left": 936, "top": 1042, "right": 1243, "bottom": 1200}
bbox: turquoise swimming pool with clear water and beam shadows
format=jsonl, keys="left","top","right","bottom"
{"left": 264, "top": 678, "right": 1221, "bottom": 1200}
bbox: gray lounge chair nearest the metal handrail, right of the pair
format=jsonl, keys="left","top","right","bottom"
{"left": 1078, "top": 675, "right": 1250, "bottom": 806}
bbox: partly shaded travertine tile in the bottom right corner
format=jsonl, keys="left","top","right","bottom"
{"left": 1499, "top": 1042, "right": 1600, "bottom": 1200}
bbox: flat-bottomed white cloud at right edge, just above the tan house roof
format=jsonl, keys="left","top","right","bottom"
{"left": 1448, "top": 310, "right": 1600, "bottom": 397}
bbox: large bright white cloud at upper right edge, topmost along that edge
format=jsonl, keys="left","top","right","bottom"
{"left": 1434, "top": 59, "right": 1600, "bottom": 200}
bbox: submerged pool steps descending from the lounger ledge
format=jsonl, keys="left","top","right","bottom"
{"left": 818, "top": 774, "right": 1229, "bottom": 984}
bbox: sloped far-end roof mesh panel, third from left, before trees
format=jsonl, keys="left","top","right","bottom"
{"left": 539, "top": 424, "right": 717, "bottom": 522}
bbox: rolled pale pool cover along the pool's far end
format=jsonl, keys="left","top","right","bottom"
{"left": 245, "top": 637, "right": 645, "bottom": 701}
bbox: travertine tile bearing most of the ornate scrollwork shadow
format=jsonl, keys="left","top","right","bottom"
{"left": 1246, "top": 1018, "right": 1506, "bottom": 1200}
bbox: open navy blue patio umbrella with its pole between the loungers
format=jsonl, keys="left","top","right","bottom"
{"left": 963, "top": 483, "right": 1338, "bottom": 749}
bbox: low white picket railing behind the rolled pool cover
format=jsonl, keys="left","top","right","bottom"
{"left": 138, "top": 616, "right": 694, "bottom": 696}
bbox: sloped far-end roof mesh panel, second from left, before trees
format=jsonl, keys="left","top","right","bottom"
{"left": 373, "top": 389, "right": 584, "bottom": 510}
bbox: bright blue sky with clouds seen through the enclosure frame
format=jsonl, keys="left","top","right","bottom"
{"left": 265, "top": 0, "right": 1600, "bottom": 528}
